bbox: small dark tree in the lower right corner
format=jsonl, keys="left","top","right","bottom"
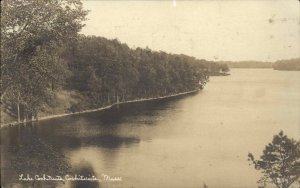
{"left": 248, "top": 131, "right": 300, "bottom": 188}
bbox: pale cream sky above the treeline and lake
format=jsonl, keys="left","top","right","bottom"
{"left": 82, "top": 0, "right": 300, "bottom": 61}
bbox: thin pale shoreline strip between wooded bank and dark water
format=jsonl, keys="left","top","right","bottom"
{"left": 1, "top": 89, "right": 200, "bottom": 128}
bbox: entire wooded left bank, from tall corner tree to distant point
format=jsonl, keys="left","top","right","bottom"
{"left": 1, "top": 0, "right": 229, "bottom": 122}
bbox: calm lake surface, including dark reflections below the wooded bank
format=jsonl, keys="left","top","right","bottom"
{"left": 1, "top": 69, "right": 300, "bottom": 188}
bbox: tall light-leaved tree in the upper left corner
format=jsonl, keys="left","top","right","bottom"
{"left": 1, "top": 0, "right": 87, "bottom": 120}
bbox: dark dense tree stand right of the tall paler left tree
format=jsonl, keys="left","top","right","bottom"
{"left": 63, "top": 36, "right": 208, "bottom": 106}
